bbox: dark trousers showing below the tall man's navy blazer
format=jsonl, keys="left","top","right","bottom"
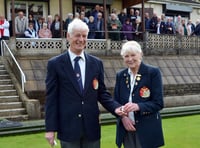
{"left": 60, "top": 139, "right": 100, "bottom": 148}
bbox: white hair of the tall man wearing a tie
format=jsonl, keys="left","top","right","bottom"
{"left": 67, "top": 18, "right": 89, "bottom": 35}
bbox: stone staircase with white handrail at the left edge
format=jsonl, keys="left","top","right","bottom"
{"left": 0, "top": 59, "right": 28, "bottom": 121}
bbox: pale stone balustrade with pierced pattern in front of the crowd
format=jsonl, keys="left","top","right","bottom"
{"left": 12, "top": 33, "right": 200, "bottom": 55}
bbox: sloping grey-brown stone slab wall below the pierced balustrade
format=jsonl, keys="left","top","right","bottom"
{"left": 13, "top": 56, "right": 200, "bottom": 110}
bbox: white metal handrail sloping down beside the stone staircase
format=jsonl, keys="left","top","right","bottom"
{"left": 1, "top": 40, "right": 26, "bottom": 92}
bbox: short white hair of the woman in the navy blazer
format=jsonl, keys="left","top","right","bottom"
{"left": 121, "top": 41, "right": 143, "bottom": 57}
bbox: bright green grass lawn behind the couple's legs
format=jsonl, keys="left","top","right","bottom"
{"left": 0, "top": 115, "right": 200, "bottom": 148}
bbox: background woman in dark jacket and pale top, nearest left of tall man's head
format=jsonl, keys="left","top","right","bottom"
{"left": 50, "top": 14, "right": 62, "bottom": 38}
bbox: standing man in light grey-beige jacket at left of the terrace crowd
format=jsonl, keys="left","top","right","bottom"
{"left": 15, "top": 11, "right": 28, "bottom": 38}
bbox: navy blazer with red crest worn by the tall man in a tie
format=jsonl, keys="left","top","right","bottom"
{"left": 45, "top": 51, "right": 120, "bottom": 142}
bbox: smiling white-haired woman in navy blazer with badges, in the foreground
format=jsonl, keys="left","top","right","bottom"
{"left": 114, "top": 41, "right": 164, "bottom": 148}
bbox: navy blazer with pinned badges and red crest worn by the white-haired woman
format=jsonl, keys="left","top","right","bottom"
{"left": 114, "top": 62, "right": 164, "bottom": 148}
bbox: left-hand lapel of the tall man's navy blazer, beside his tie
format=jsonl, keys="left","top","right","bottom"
{"left": 60, "top": 51, "right": 82, "bottom": 95}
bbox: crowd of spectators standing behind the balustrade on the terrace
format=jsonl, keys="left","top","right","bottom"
{"left": 0, "top": 5, "right": 200, "bottom": 41}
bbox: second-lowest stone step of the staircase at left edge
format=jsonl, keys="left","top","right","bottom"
{"left": 0, "top": 108, "right": 26, "bottom": 117}
